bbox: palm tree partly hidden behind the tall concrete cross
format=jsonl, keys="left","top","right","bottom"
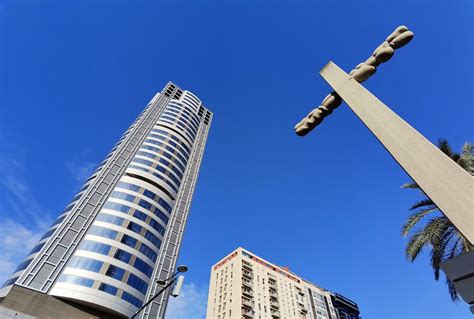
{"left": 402, "top": 139, "right": 474, "bottom": 301}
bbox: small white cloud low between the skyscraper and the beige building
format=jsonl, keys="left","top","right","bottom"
{"left": 165, "top": 283, "right": 208, "bottom": 319}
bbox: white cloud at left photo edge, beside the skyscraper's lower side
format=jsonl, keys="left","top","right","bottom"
{"left": 0, "top": 220, "right": 43, "bottom": 284}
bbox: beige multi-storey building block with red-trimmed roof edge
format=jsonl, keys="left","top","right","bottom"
{"left": 206, "top": 248, "right": 360, "bottom": 319}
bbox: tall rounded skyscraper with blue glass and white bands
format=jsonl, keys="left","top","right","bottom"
{"left": 0, "top": 83, "right": 212, "bottom": 318}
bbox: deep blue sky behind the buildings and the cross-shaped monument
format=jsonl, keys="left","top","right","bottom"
{"left": 0, "top": 0, "right": 474, "bottom": 319}
